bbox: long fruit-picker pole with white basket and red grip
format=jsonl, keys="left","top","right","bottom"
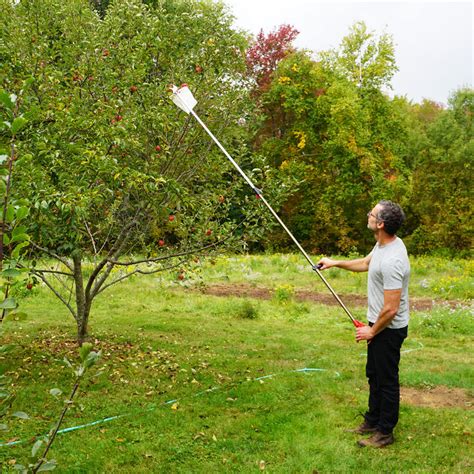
{"left": 171, "top": 84, "right": 364, "bottom": 327}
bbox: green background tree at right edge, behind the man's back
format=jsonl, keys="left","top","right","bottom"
{"left": 409, "top": 89, "right": 474, "bottom": 255}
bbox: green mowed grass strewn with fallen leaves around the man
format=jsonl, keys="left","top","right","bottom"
{"left": 0, "top": 256, "right": 474, "bottom": 473}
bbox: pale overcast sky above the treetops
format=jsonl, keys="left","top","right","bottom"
{"left": 223, "top": 0, "right": 473, "bottom": 104}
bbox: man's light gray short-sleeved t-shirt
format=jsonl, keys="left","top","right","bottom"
{"left": 367, "top": 237, "right": 410, "bottom": 329}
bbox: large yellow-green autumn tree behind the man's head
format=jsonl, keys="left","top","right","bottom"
{"left": 252, "top": 24, "right": 410, "bottom": 252}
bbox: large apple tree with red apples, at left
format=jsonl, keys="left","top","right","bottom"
{"left": 0, "top": 0, "right": 286, "bottom": 343}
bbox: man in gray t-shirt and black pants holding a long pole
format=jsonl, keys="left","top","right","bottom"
{"left": 319, "top": 201, "right": 410, "bottom": 448}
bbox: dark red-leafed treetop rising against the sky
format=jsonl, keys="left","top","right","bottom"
{"left": 246, "top": 25, "right": 299, "bottom": 91}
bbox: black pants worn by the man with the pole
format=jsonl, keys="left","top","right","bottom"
{"left": 365, "top": 324, "right": 408, "bottom": 434}
